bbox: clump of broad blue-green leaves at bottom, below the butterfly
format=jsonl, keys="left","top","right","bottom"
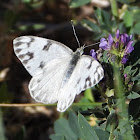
{"left": 50, "top": 112, "right": 109, "bottom": 140}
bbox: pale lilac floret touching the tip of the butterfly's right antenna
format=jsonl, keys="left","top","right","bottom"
{"left": 99, "top": 34, "right": 113, "bottom": 51}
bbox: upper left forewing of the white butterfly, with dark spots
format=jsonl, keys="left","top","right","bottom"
{"left": 13, "top": 36, "right": 73, "bottom": 76}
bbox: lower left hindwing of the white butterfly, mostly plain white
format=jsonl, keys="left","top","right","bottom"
{"left": 29, "top": 58, "right": 70, "bottom": 104}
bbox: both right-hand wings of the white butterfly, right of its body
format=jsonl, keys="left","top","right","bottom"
{"left": 57, "top": 55, "right": 104, "bottom": 112}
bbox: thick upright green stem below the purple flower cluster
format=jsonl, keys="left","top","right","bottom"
{"left": 113, "top": 64, "right": 134, "bottom": 140}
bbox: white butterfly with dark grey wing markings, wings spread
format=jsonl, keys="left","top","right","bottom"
{"left": 13, "top": 36, "right": 104, "bottom": 112}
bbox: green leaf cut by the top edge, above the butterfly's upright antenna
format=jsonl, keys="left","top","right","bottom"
{"left": 69, "top": 0, "right": 91, "bottom": 8}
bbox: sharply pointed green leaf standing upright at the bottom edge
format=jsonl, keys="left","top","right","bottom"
{"left": 78, "top": 113, "right": 99, "bottom": 140}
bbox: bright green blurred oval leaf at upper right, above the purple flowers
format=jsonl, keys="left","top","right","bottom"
{"left": 123, "top": 10, "right": 133, "bottom": 27}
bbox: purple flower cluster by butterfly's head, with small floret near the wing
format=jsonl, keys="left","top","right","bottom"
{"left": 91, "top": 30, "right": 134, "bottom": 64}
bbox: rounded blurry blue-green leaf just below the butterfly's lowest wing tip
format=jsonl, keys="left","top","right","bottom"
{"left": 54, "top": 119, "right": 77, "bottom": 140}
